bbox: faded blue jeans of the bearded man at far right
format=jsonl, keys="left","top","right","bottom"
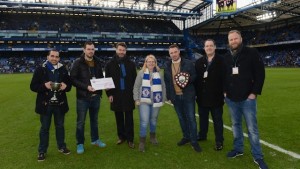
{"left": 225, "top": 98, "right": 263, "bottom": 159}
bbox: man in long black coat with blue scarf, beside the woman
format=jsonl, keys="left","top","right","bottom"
{"left": 105, "top": 42, "right": 137, "bottom": 148}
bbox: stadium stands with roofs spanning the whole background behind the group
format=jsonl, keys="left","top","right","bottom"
{"left": 0, "top": 0, "right": 300, "bottom": 73}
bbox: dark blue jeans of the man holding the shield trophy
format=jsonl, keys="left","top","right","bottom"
{"left": 173, "top": 95, "right": 197, "bottom": 143}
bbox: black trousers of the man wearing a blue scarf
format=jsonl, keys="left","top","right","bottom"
{"left": 115, "top": 111, "right": 134, "bottom": 142}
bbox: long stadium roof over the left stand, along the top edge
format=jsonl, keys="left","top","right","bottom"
{"left": 0, "top": 0, "right": 212, "bottom": 20}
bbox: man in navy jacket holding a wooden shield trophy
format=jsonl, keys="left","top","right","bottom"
{"left": 164, "top": 45, "right": 201, "bottom": 152}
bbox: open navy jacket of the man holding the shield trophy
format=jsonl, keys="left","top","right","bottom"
{"left": 164, "top": 58, "right": 196, "bottom": 102}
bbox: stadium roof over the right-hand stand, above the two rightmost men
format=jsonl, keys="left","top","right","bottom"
{"left": 193, "top": 0, "right": 300, "bottom": 32}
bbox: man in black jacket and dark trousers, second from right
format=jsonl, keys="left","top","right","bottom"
{"left": 195, "top": 39, "right": 225, "bottom": 150}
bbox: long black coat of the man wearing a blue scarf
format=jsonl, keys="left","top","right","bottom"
{"left": 105, "top": 55, "right": 137, "bottom": 112}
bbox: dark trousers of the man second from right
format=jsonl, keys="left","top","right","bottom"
{"left": 198, "top": 106, "right": 224, "bottom": 143}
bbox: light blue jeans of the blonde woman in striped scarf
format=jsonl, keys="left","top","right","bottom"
{"left": 139, "top": 103, "right": 160, "bottom": 137}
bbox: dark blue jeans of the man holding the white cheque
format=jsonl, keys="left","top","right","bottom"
{"left": 76, "top": 95, "right": 100, "bottom": 144}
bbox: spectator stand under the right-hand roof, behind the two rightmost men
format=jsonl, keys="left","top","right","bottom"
{"left": 193, "top": 24, "right": 300, "bottom": 67}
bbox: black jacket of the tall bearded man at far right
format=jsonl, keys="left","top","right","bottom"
{"left": 225, "top": 46, "right": 265, "bottom": 102}
